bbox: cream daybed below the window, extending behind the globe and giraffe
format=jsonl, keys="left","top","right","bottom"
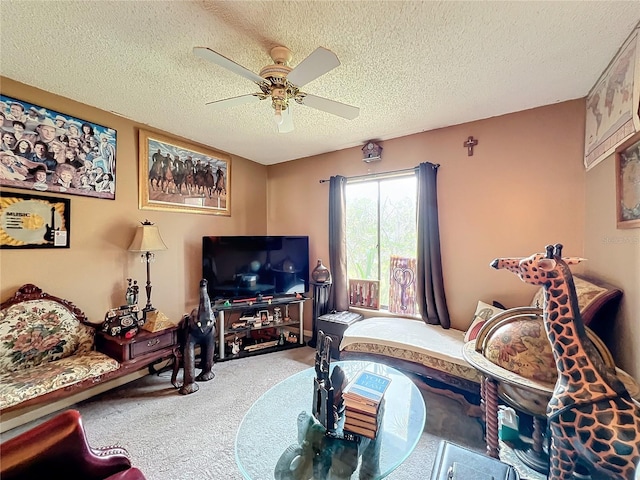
{"left": 340, "top": 275, "right": 622, "bottom": 401}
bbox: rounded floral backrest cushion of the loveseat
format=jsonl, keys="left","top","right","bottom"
{"left": 0, "top": 299, "right": 95, "bottom": 372}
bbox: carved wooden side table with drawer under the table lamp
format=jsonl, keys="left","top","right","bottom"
{"left": 96, "top": 325, "right": 179, "bottom": 370}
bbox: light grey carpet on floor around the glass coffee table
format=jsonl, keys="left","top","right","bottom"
{"left": 2, "top": 347, "right": 485, "bottom": 480}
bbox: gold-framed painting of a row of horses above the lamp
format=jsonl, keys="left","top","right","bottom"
{"left": 139, "top": 130, "right": 231, "bottom": 216}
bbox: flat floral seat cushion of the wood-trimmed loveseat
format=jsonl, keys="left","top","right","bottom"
{"left": 0, "top": 351, "right": 120, "bottom": 410}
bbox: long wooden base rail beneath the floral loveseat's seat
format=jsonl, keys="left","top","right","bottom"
{"left": 0, "top": 367, "right": 149, "bottom": 433}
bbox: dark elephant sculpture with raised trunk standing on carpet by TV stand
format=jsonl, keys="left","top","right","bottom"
{"left": 171, "top": 279, "right": 216, "bottom": 395}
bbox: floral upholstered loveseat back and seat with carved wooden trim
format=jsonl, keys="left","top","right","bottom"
{"left": 0, "top": 284, "right": 120, "bottom": 413}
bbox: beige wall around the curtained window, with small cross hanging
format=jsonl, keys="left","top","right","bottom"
{"left": 268, "top": 101, "right": 585, "bottom": 329}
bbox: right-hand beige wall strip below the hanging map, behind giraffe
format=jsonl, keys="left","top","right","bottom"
{"left": 584, "top": 148, "right": 640, "bottom": 379}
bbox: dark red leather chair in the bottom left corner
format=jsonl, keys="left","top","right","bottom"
{"left": 0, "top": 410, "right": 145, "bottom": 480}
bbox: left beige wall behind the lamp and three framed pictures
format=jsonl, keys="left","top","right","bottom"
{"left": 0, "top": 78, "right": 267, "bottom": 322}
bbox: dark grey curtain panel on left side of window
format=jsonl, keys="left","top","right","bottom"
{"left": 329, "top": 175, "right": 349, "bottom": 312}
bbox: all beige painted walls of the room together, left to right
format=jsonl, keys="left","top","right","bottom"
{"left": 0, "top": 78, "right": 640, "bottom": 378}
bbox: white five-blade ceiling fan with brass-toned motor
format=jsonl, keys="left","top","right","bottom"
{"left": 193, "top": 47, "right": 360, "bottom": 133}
